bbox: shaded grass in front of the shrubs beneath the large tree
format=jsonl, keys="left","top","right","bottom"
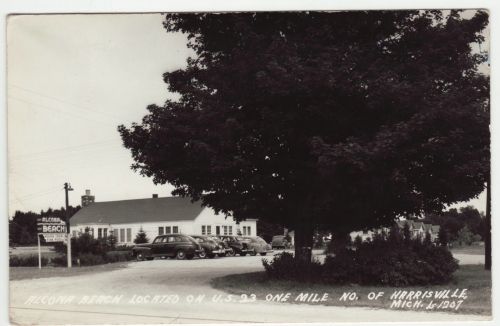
{"left": 212, "top": 265, "right": 491, "bottom": 315}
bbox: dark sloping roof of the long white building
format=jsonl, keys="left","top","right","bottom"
{"left": 70, "top": 197, "right": 203, "bottom": 225}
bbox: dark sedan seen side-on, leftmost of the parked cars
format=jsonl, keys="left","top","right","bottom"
{"left": 132, "top": 234, "right": 203, "bottom": 260}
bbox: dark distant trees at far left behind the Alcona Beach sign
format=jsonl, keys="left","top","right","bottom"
{"left": 9, "top": 206, "right": 81, "bottom": 245}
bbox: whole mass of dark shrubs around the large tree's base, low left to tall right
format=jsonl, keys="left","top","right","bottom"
{"left": 263, "top": 229, "right": 458, "bottom": 286}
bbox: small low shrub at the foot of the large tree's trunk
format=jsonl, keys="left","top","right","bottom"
{"left": 262, "top": 252, "right": 321, "bottom": 281}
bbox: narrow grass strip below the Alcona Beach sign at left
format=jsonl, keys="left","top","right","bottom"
{"left": 9, "top": 262, "right": 131, "bottom": 281}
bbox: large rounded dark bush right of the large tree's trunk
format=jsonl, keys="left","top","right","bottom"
{"left": 322, "top": 229, "right": 458, "bottom": 286}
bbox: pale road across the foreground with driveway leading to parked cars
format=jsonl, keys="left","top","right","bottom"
{"left": 10, "top": 252, "right": 486, "bottom": 325}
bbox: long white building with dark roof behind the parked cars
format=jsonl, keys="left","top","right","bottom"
{"left": 70, "top": 195, "right": 257, "bottom": 244}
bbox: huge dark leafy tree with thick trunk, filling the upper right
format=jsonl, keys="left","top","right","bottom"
{"left": 119, "top": 11, "right": 489, "bottom": 259}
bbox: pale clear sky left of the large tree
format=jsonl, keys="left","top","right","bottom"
{"left": 7, "top": 14, "right": 486, "bottom": 215}
